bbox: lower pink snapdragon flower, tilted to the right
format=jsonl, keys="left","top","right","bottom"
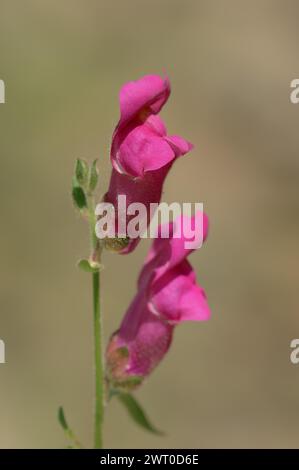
{"left": 107, "top": 214, "right": 210, "bottom": 388}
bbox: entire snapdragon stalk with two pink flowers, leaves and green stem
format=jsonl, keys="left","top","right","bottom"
{"left": 58, "top": 75, "right": 210, "bottom": 449}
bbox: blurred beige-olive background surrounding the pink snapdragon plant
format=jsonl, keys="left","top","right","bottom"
{"left": 0, "top": 0, "right": 299, "bottom": 448}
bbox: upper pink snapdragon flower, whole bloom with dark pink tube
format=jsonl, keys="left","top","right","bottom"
{"left": 104, "top": 75, "right": 192, "bottom": 254}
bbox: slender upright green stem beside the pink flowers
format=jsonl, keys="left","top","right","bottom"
{"left": 88, "top": 194, "right": 104, "bottom": 449}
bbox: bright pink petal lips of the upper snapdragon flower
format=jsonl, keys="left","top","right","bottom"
{"left": 111, "top": 75, "right": 192, "bottom": 178}
